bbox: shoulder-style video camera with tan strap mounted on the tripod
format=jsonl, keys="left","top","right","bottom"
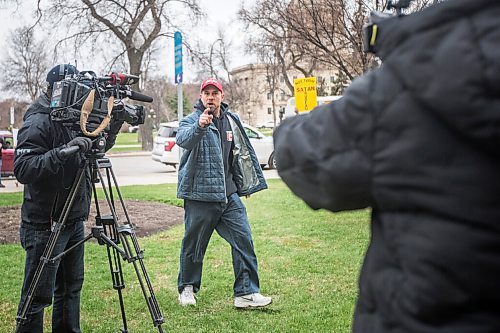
{"left": 50, "top": 71, "right": 153, "bottom": 137}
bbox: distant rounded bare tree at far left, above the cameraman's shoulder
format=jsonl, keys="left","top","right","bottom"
{"left": 0, "top": 27, "right": 49, "bottom": 101}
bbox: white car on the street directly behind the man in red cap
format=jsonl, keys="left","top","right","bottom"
{"left": 151, "top": 121, "right": 276, "bottom": 169}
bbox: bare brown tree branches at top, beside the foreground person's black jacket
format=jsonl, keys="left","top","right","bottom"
{"left": 242, "top": 0, "right": 383, "bottom": 80}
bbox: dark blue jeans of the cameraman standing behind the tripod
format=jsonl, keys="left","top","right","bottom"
{"left": 18, "top": 222, "right": 84, "bottom": 333}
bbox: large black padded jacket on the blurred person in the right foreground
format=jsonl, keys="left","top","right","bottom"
{"left": 274, "top": 0, "right": 500, "bottom": 333}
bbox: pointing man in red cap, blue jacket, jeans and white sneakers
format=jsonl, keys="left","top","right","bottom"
{"left": 176, "top": 78, "right": 272, "bottom": 308}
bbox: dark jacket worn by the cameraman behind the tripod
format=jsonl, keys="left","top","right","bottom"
{"left": 14, "top": 95, "right": 91, "bottom": 224}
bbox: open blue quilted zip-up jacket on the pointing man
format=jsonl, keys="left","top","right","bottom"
{"left": 176, "top": 100, "right": 267, "bottom": 202}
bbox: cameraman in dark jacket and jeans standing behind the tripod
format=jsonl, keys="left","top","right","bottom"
{"left": 14, "top": 65, "right": 123, "bottom": 333}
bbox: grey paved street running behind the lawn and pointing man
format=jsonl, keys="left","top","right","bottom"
{"left": 0, "top": 153, "right": 279, "bottom": 193}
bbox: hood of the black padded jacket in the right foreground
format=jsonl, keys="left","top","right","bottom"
{"left": 377, "top": 0, "right": 500, "bottom": 149}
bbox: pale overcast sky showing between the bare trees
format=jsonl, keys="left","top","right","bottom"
{"left": 0, "top": 0, "right": 249, "bottom": 80}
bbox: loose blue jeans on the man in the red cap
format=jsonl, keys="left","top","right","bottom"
{"left": 177, "top": 193, "right": 259, "bottom": 296}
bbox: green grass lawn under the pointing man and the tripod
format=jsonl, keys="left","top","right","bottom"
{"left": 0, "top": 180, "right": 369, "bottom": 333}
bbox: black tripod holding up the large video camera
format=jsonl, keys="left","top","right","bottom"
{"left": 16, "top": 150, "right": 164, "bottom": 333}
